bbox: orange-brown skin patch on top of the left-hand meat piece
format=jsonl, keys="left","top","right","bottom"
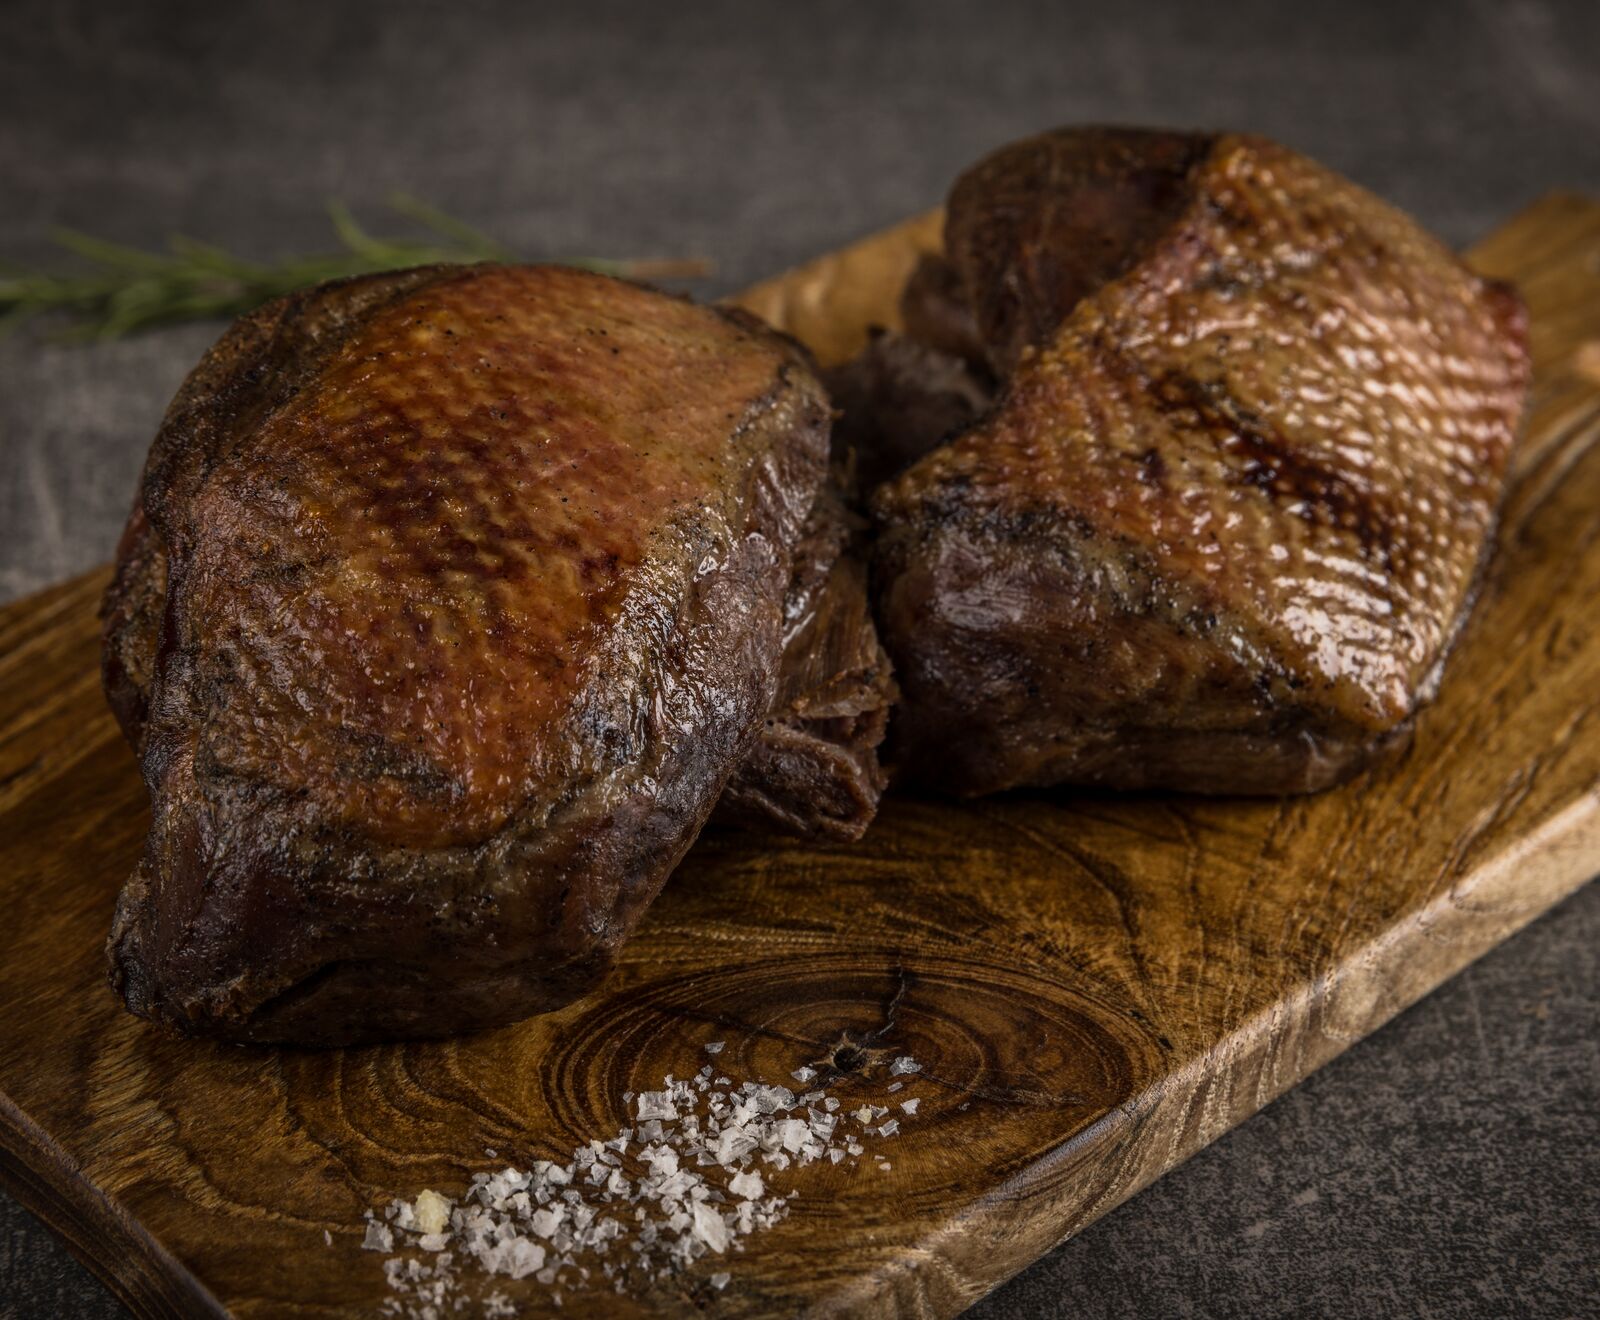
{"left": 174, "top": 267, "right": 782, "bottom": 843}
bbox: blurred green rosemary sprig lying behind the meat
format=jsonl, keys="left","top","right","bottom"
{"left": 0, "top": 195, "right": 707, "bottom": 339}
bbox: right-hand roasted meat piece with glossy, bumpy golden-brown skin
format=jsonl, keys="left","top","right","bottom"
{"left": 874, "top": 130, "right": 1528, "bottom": 794}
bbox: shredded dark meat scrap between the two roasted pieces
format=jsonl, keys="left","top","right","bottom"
{"left": 712, "top": 485, "right": 894, "bottom": 840}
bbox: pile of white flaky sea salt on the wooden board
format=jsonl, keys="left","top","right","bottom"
{"left": 362, "top": 1042, "right": 918, "bottom": 1320}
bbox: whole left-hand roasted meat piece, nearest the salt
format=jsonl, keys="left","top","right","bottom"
{"left": 104, "top": 266, "right": 829, "bottom": 1045}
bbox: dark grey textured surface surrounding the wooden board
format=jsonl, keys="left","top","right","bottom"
{"left": 0, "top": 0, "right": 1600, "bottom": 1320}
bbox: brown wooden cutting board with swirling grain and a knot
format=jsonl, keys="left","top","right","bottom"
{"left": 0, "top": 197, "right": 1600, "bottom": 1317}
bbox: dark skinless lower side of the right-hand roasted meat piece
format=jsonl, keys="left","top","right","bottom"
{"left": 874, "top": 492, "right": 1411, "bottom": 797}
